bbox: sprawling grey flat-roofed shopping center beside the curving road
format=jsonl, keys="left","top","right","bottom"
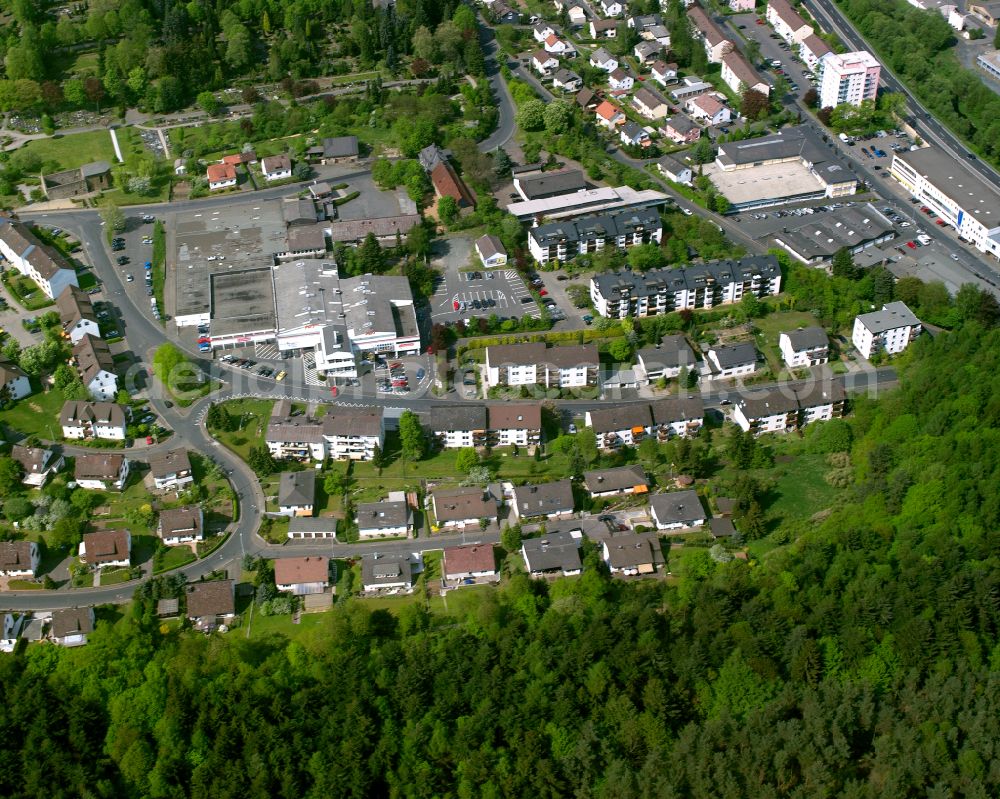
{"left": 170, "top": 200, "right": 420, "bottom": 375}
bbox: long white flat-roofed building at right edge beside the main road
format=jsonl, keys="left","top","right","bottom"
{"left": 889, "top": 147, "right": 1000, "bottom": 258}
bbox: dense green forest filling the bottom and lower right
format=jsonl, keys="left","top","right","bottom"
{"left": 0, "top": 318, "right": 1000, "bottom": 799}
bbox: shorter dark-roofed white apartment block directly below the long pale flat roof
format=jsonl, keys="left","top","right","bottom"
{"left": 528, "top": 208, "right": 663, "bottom": 264}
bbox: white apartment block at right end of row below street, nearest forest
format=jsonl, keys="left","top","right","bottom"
{"left": 733, "top": 383, "right": 846, "bottom": 435}
